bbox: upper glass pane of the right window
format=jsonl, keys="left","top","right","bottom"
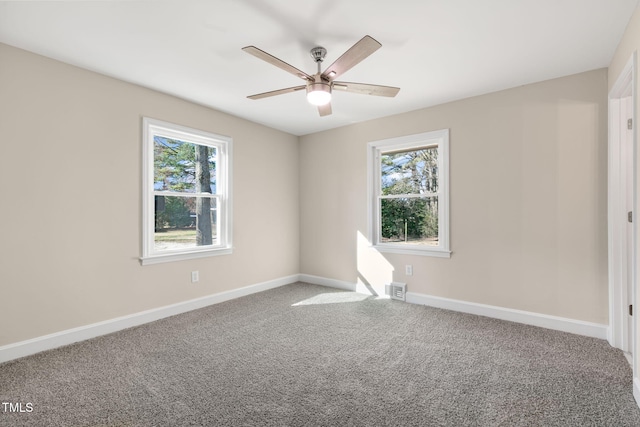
{"left": 380, "top": 147, "right": 438, "bottom": 195}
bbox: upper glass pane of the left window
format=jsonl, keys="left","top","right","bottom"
{"left": 153, "top": 135, "right": 217, "bottom": 194}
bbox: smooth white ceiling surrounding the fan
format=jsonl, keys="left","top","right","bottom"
{"left": 0, "top": 0, "right": 639, "bottom": 135}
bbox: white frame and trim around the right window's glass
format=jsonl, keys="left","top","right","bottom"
{"left": 367, "top": 129, "right": 451, "bottom": 258}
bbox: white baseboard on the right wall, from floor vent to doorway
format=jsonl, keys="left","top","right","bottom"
{"left": 406, "top": 292, "right": 609, "bottom": 340}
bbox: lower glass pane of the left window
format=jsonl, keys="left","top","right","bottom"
{"left": 154, "top": 196, "right": 218, "bottom": 251}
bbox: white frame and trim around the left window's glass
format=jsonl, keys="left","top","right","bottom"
{"left": 140, "top": 117, "right": 233, "bottom": 265}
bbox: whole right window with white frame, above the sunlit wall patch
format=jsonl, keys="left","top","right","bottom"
{"left": 368, "top": 129, "right": 451, "bottom": 258}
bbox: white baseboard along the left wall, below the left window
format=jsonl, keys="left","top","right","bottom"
{"left": 0, "top": 274, "right": 299, "bottom": 363}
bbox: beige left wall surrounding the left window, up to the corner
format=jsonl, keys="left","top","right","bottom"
{"left": 0, "top": 44, "right": 299, "bottom": 346}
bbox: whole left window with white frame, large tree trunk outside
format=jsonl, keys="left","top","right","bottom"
{"left": 141, "top": 118, "right": 232, "bottom": 265}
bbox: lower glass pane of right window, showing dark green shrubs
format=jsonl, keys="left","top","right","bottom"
{"left": 380, "top": 196, "right": 438, "bottom": 246}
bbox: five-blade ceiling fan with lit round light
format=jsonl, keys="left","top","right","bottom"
{"left": 242, "top": 36, "right": 400, "bottom": 116}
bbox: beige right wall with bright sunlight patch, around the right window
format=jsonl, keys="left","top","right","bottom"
{"left": 300, "top": 69, "right": 608, "bottom": 324}
